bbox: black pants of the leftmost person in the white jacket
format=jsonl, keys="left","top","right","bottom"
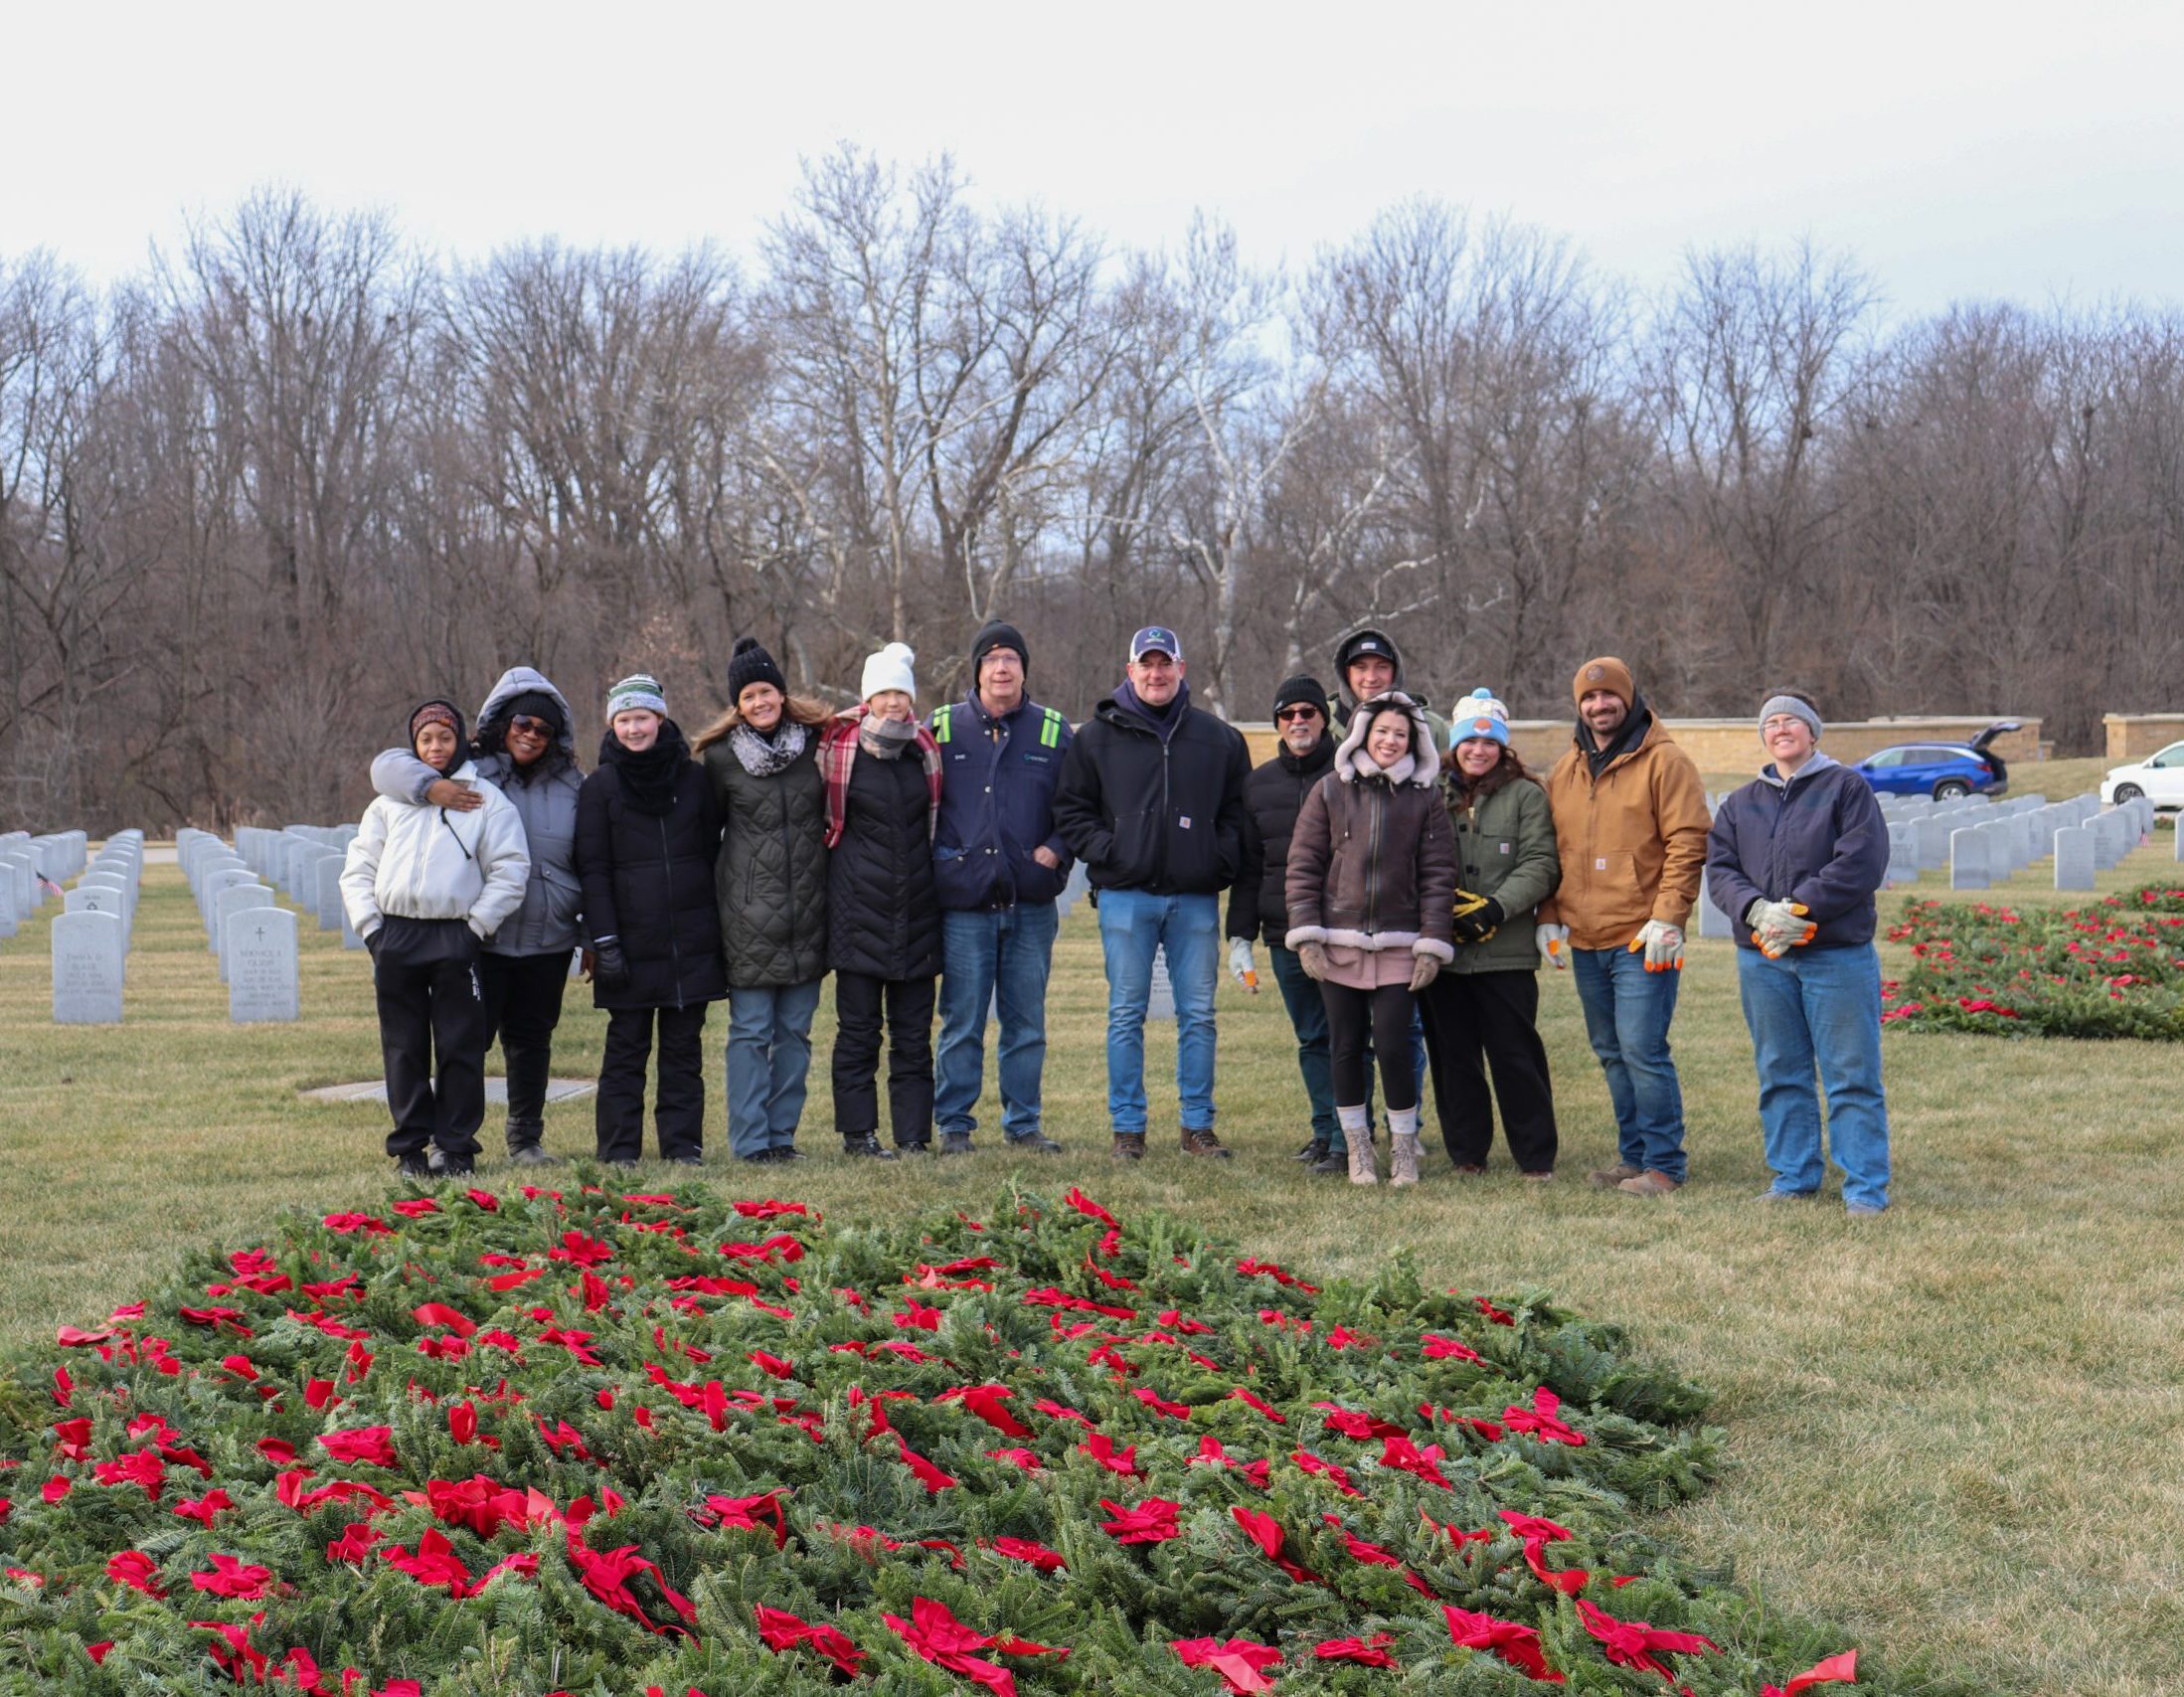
{"left": 371, "top": 916, "right": 487, "bottom": 1162}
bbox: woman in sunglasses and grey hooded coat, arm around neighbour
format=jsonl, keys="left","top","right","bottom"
{"left": 371, "top": 666, "right": 584, "bottom": 1166}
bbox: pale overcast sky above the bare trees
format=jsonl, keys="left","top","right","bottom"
{"left": 0, "top": 0, "right": 2184, "bottom": 312}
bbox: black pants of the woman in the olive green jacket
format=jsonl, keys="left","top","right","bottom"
{"left": 1427, "top": 969, "right": 1557, "bottom": 1173}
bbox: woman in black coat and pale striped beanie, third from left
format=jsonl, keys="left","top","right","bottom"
{"left": 577, "top": 673, "right": 728, "bottom": 1166}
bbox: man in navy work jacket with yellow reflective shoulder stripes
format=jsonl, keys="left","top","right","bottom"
{"left": 928, "top": 618, "right": 1071, "bottom": 1155}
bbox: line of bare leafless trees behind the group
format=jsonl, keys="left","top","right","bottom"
{"left": 0, "top": 148, "right": 2184, "bottom": 828}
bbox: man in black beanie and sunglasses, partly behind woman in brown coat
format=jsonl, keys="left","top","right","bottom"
{"left": 1228, "top": 673, "right": 1350, "bottom": 1173}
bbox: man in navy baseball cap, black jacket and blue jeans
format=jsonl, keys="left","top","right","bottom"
{"left": 1055, "top": 624, "right": 1252, "bottom": 1160}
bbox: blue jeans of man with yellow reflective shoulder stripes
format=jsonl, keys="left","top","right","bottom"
{"left": 932, "top": 902, "right": 1062, "bottom": 1142}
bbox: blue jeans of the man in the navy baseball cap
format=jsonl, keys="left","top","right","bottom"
{"left": 1098, "top": 889, "right": 1221, "bottom": 1133}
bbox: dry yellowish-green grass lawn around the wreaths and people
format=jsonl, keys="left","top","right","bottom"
{"left": 0, "top": 847, "right": 2184, "bottom": 1697}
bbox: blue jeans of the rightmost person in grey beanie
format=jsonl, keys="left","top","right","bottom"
{"left": 1737, "top": 943, "right": 1889, "bottom": 1208}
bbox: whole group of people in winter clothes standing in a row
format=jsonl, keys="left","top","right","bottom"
{"left": 343, "top": 620, "right": 1889, "bottom": 1214}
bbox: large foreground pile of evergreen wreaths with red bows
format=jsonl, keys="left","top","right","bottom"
{"left": 0, "top": 1184, "right": 1895, "bottom": 1697}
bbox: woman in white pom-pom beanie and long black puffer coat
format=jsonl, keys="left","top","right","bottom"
{"left": 819, "top": 642, "right": 941, "bottom": 1160}
